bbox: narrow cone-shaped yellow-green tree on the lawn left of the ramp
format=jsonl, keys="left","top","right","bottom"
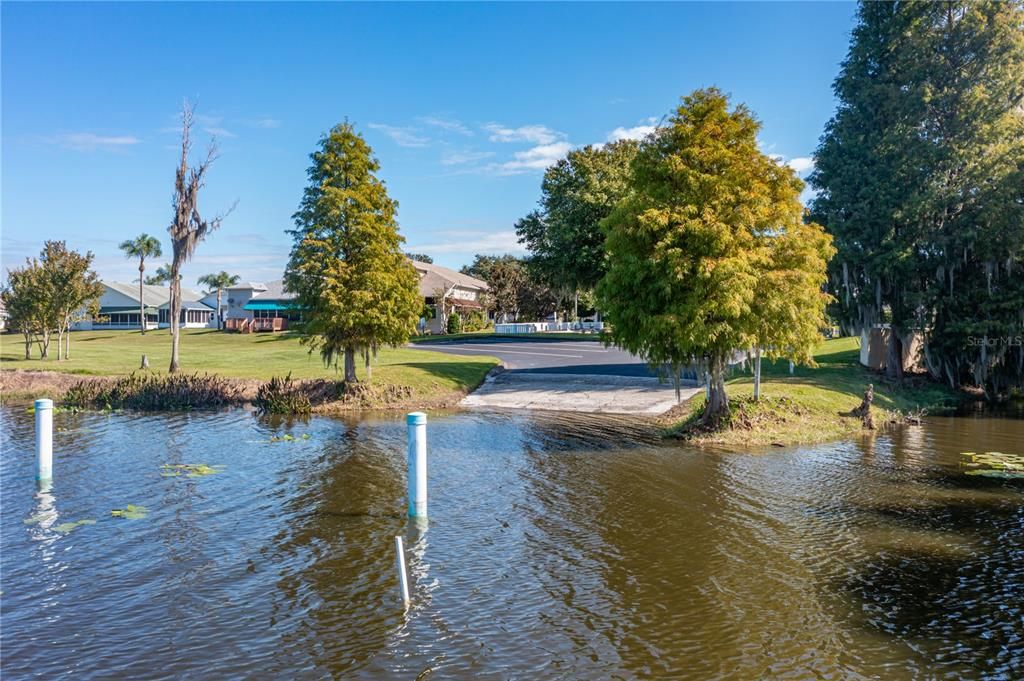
{"left": 285, "top": 122, "right": 423, "bottom": 382}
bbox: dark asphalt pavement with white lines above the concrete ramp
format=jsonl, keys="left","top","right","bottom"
{"left": 414, "top": 338, "right": 655, "bottom": 377}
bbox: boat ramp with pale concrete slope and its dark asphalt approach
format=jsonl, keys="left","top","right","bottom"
{"left": 415, "top": 338, "right": 701, "bottom": 415}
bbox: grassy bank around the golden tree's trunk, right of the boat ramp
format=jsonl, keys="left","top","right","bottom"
{"left": 658, "top": 338, "right": 961, "bottom": 448}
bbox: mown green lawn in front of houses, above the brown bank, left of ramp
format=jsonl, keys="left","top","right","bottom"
{"left": 0, "top": 329, "right": 498, "bottom": 396}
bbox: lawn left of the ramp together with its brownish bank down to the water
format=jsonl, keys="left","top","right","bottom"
{"left": 0, "top": 329, "right": 499, "bottom": 412}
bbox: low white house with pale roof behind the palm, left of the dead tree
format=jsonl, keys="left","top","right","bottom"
{"left": 74, "top": 282, "right": 217, "bottom": 331}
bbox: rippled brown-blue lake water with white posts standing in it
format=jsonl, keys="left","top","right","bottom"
{"left": 0, "top": 407, "right": 1024, "bottom": 680}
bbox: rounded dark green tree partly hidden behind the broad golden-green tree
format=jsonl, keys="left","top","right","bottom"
{"left": 515, "top": 139, "right": 638, "bottom": 319}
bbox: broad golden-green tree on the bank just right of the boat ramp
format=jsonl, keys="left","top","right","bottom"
{"left": 597, "top": 88, "right": 823, "bottom": 423}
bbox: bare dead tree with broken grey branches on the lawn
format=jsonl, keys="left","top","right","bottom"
{"left": 167, "top": 99, "right": 238, "bottom": 374}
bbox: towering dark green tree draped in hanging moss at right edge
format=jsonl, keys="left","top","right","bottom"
{"left": 810, "top": 1, "right": 1024, "bottom": 393}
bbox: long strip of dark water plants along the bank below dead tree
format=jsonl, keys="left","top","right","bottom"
{"left": 63, "top": 373, "right": 244, "bottom": 411}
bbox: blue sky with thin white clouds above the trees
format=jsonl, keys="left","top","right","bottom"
{"left": 0, "top": 2, "right": 855, "bottom": 286}
